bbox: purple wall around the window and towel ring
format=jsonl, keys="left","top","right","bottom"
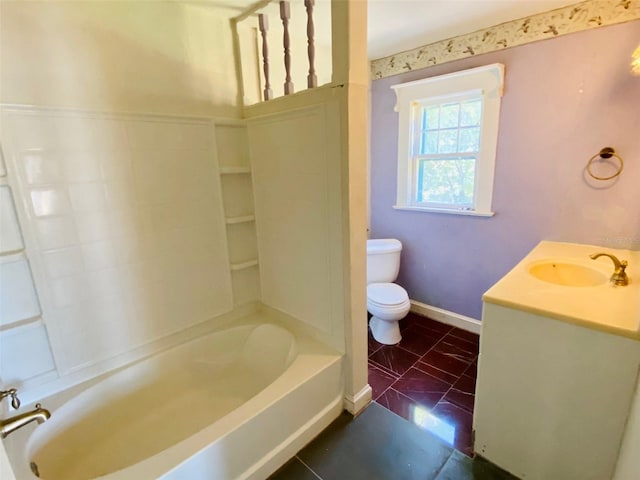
{"left": 371, "top": 21, "right": 640, "bottom": 319}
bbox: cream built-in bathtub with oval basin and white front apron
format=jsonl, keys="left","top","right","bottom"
{"left": 25, "top": 323, "right": 343, "bottom": 480}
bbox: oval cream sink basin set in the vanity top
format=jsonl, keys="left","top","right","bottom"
{"left": 529, "top": 260, "right": 609, "bottom": 287}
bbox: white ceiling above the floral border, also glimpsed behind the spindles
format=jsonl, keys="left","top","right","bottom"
{"left": 212, "top": 0, "right": 578, "bottom": 60}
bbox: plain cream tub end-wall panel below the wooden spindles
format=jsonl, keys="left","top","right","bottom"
{"left": 249, "top": 103, "right": 344, "bottom": 351}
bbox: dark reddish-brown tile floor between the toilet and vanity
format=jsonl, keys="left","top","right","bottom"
{"left": 369, "top": 313, "right": 480, "bottom": 456}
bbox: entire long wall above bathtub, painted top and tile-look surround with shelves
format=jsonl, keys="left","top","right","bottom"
{"left": 0, "top": 1, "right": 255, "bottom": 403}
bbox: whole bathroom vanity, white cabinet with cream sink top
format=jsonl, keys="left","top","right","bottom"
{"left": 474, "top": 241, "right": 640, "bottom": 480}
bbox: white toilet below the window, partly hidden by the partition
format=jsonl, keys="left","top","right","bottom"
{"left": 367, "top": 238, "right": 411, "bottom": 345}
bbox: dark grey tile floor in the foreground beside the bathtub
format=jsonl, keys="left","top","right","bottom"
{"left": 270, "top": 402, "right": 517, "bottom": 480}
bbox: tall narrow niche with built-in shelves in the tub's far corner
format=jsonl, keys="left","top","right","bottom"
{"left": 216, "top": 124, "right": 260, "bottom": 305}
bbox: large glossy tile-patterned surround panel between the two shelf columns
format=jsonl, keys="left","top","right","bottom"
{"left": 3, "top": 109, "right": 233, "bottom": 373}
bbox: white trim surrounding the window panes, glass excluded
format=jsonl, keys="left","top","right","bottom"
{"left": 391, "top": 63, "right": 504, "bottom": 217}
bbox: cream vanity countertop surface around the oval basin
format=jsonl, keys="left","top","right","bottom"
{"left": 482, "top": 241, "right": 640, "bottom": 340}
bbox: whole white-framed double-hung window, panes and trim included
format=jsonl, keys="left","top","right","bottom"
{"left": 392, "top": 64, "right": 504, "bottom": 216}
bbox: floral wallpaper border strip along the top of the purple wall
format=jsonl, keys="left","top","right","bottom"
{"left": 371, "top": 0, "right": 640, "bottom": 80}
